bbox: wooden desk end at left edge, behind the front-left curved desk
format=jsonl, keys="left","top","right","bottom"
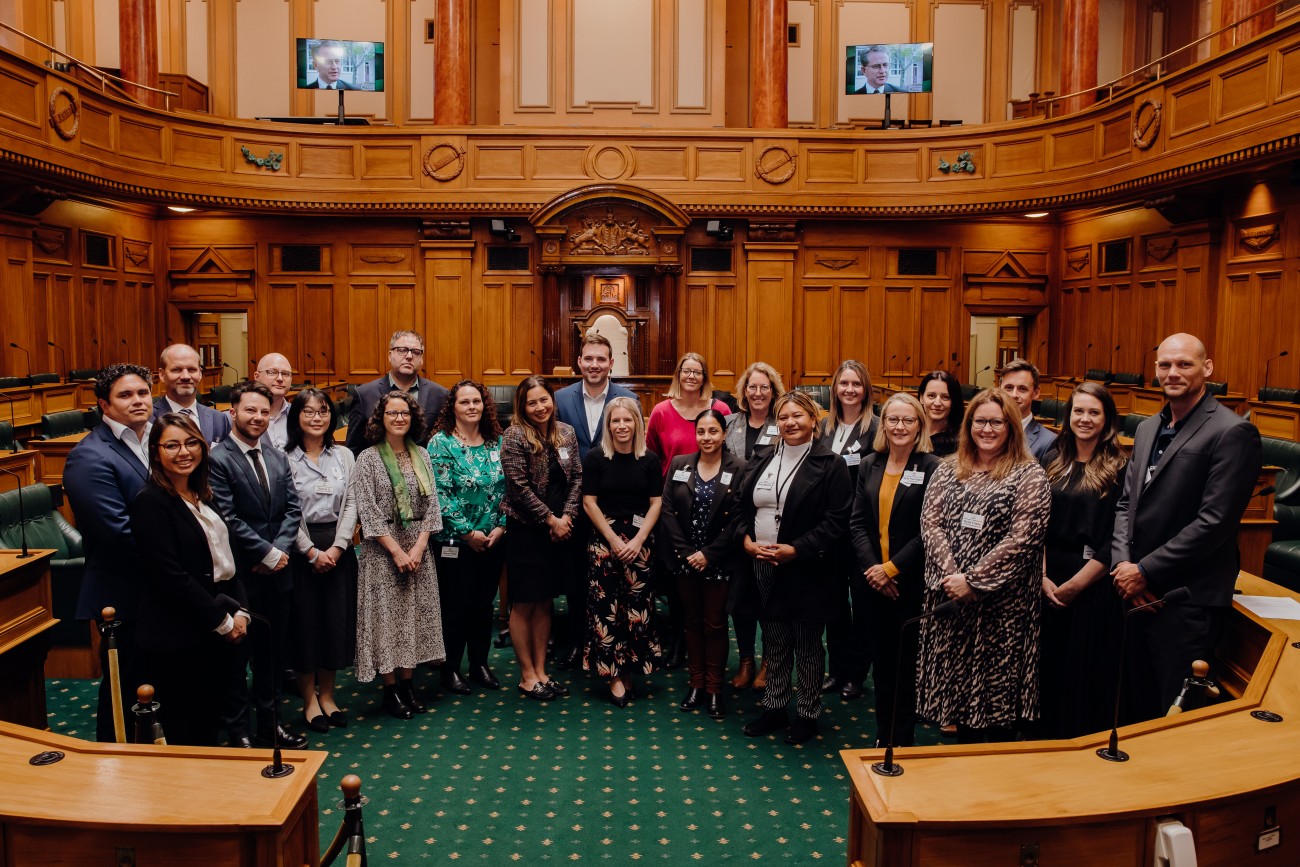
{"left": 0, "top": 549, "right": 59, "bottom": 733}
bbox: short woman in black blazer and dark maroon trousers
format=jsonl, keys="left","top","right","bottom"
{"left": 659, "top": 409, "right": 745, "bottom": 719}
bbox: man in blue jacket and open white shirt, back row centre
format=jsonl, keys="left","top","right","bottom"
{"left": 555, "top": 331, "right": 636, "bottom": 671}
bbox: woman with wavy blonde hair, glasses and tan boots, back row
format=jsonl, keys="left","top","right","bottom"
{"left": 722, "top": 361, "right": 785, "bottom": 689}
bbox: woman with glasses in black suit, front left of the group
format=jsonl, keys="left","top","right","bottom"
{"left": 130, "top": 413, "right": 248, "bottom": 746}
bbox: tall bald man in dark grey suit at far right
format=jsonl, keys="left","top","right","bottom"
{"left": 1110, "top": 334, "right": 1262, "bottom": 719}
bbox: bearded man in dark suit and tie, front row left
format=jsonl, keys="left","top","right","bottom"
{"left": 209, "top": 382, "right": 307, "bottom": 749}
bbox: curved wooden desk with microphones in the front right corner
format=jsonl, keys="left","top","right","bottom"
{"left": 840, "top": 573, "right": 1300, "bottom": 867}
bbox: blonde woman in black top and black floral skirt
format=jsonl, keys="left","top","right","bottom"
{"left": 582, "top": 398, "right": 663, "bottom": 707}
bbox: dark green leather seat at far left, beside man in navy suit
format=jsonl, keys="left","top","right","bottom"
{"left": 0, "top": 484, "right": 90, "bottom": 646}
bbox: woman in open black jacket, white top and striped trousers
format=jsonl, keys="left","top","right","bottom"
{"left": 732, "top": 391, "right": 853, "bottom": 744}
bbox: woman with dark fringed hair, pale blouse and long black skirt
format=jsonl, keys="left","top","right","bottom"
{"left": 286, "top": 389, "right": 356, "bottom": 732}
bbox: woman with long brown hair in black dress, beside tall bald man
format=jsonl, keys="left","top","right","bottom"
{"left": 1040, "top": 382, "right": 1127, "bottom": 737}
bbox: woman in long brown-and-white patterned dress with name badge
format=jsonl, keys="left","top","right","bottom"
{"left": 917, "top": 389, "right": 1052, "bottom": 744}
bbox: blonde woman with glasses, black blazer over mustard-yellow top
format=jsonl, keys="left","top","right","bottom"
{"left": 849, "top": 391, "right": 939, "bottom": 746}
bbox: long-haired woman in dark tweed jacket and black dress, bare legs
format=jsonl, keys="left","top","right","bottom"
{"left": 501, "top": 376, "right": 582, "bottom": 702}
